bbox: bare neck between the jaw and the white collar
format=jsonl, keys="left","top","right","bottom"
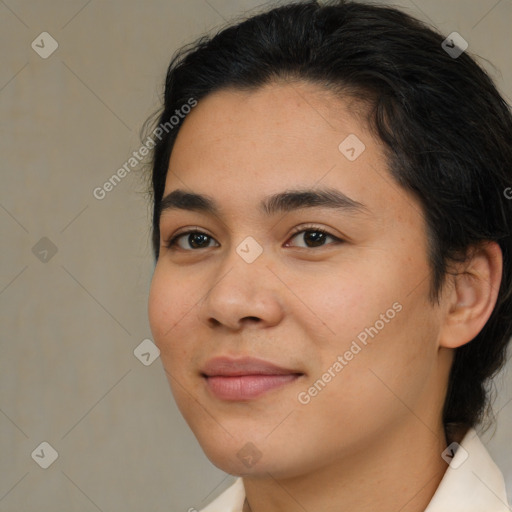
{"left": 243, "top": 418, "right": 447, "bottom": 512}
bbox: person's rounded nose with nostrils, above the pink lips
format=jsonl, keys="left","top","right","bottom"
{"left": 198, "top": 250, "right": 284, "bottom": 331}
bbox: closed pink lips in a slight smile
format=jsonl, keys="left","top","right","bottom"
{"left": 202, "top": 357, "right": 303, "bottom": 401}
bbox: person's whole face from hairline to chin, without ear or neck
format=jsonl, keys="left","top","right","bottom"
{"left": 149, "top": 83, "right": 445, "bottom": 477}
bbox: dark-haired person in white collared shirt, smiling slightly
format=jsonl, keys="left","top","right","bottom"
{"left": 145, "top": 2, "right": 512, "bottom": 512}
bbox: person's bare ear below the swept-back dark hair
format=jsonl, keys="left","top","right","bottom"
{"left": 439, "top": 242, "right": 503, "bottom": 348}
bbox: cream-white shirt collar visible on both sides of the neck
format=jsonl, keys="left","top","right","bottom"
{"left": 201, "top": 429, "right": 512, "bottom": 512}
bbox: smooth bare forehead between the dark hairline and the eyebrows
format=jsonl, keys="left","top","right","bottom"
{"left": 164, "top": 83, "right": 420, "bottom": 227}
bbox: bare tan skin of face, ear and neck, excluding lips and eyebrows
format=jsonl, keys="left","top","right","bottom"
{"left": 149, "top": 82, "right": 501, "bottom": 512}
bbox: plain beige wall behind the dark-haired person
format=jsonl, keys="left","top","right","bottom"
{"left": 0, "top": 0, "right": 512, "bottom": 512}
